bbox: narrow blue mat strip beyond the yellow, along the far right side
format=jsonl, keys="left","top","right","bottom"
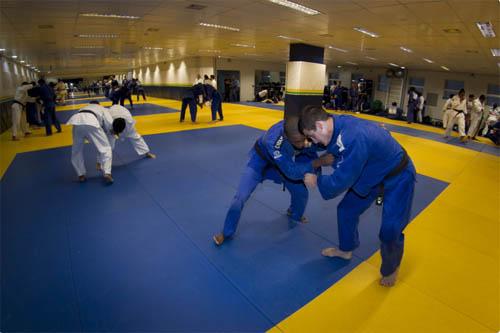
{"left": 233, "top": 102, "right": 500, "bottom": 156}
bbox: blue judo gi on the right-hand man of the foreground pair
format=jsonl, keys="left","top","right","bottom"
{"left": 318, "top": 116, "right": 416, "bottom": 276}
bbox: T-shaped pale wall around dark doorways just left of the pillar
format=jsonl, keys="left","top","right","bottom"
{"left": 216, "top": 58, "right": 286, "bottom": 101}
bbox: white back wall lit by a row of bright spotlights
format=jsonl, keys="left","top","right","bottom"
{"left": 132, "top": 57, "right": 214, "bottom": 86}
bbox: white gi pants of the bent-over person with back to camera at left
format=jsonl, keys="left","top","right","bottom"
{"left": 71, "top": 125, "right": 113, "bottom": 176}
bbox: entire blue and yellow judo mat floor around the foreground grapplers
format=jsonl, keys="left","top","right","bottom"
{"left": 0, "top": 99, "right": 500, "bottom": 332}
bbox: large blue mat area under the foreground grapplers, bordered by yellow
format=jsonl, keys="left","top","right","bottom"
{"left": 1, "top": 126, "right": 447, "bottom": 332}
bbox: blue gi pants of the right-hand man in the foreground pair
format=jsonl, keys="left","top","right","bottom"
{"left": 337, "top": 161, "right": 415, "bottom": 276}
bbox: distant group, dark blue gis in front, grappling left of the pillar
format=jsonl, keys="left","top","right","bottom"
{"left": 180, "top": 74, "right": 224, "bottom": 123}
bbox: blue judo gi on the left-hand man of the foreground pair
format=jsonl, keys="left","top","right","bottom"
{"left": 223, "top": 121, "right": 317, "bottom": 238}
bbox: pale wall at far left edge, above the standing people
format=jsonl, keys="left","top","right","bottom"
{"left": 0, "top": 57, "right": 38, "bottom": 100}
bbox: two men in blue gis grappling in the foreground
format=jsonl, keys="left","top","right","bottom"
{"left": 213, "top": 106, "right": 416, "bottom": 286}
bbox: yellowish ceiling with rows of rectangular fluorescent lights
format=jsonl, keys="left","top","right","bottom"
{"left": 0, "top": 0, "right": 500, "bottom": 74}
